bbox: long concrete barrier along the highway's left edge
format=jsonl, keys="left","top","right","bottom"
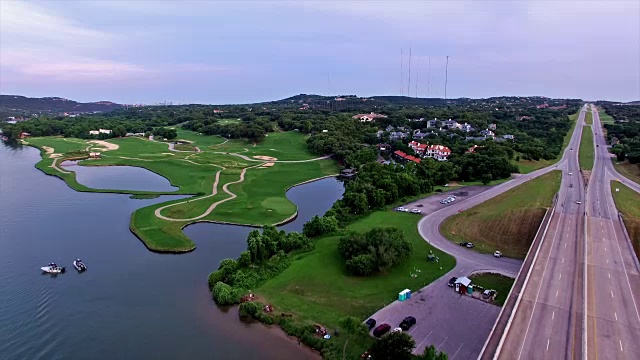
{"left": 478, "top": 193, "right": 558, "bottom": 360}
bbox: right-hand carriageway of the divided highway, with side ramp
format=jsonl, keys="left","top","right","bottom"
{"left": 587, "top": 108, "right": 640, "bottom": 359}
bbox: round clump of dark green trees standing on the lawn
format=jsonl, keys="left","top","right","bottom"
{"left": 338, "top": 227, "right": 413, "bottom": 276}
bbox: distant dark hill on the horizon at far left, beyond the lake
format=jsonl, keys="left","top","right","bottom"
{"left": 0, "top": 95, "right": 123, "bottom": 115}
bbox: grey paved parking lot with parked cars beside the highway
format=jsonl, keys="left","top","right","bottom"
{"left": 364, "top": 274, "right": 500, "bottom": 359}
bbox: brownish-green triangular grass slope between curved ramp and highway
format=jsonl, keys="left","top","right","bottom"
{"left": 440, "top": 171, "right": 561, "bottom": 259}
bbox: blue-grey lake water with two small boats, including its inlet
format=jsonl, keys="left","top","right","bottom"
{"left": 0, "top": 144, "right": 343, "bottom": 360}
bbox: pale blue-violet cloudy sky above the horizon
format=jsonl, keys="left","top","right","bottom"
{"left": 0, "top": 0, "right": 640, "bottom": 104}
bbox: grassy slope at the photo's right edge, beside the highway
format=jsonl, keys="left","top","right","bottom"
{"left": 611, "top": 181, "right": 640, "bottom": 258}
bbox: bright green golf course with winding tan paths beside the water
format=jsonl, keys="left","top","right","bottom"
{"left": 24, "top": 129, "right": 338, "bottom": 252}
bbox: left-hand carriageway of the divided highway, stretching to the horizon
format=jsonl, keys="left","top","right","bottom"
{"left": 496, "top": 107, "right": 586, "bottom": 359}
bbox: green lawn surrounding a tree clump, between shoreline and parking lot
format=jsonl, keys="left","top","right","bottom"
{"left": 256, "top": 211, "right": 455, "bottom": 359}
